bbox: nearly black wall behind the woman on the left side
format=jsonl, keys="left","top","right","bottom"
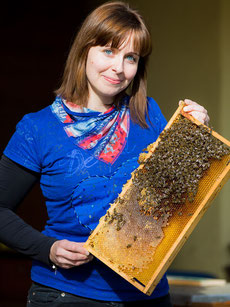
{"left": 0, "top": 0, "right": 104, "bottom": 307}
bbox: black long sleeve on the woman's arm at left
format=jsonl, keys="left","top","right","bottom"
{"left": 0, "top": 155, "right": 57, "bottom": 264}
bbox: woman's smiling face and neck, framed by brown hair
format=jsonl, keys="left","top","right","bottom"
{"left": 86, "top": 35, "right": 139, "bottom": 111}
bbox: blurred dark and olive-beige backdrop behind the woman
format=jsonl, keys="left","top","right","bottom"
{"left": 0, "top": 0, "right": 230, "bottom": 307}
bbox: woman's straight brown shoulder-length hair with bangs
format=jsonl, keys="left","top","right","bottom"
{"left": 55, "top": 1, "right": 152, "bottom": 127}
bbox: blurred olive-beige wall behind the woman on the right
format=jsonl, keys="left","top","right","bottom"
{"left": 128, "top": 0, "right": 230, "bottom": 276}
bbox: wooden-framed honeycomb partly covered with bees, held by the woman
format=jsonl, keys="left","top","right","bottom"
{"left": 85, "top": 105, "right": 230, "bottom": 295}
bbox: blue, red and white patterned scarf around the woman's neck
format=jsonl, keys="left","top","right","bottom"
{"left": 51, "top": 96, "right": 130, "bottom": 164}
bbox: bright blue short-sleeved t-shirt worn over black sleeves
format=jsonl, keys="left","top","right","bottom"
{"left": 4, "top": 98, "right": 169, "bottom": 301}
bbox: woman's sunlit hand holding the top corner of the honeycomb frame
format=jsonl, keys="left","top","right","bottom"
{"left": 179, "top": 99, "right": 210, "bottom": 125}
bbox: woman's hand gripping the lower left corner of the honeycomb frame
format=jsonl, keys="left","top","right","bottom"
{"left": 49, "top": 240, "right": 93, "bottom": 269}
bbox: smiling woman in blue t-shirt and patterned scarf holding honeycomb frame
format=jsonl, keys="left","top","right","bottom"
{"left": 0, "top": 2, "right": 208, "bottom": 306}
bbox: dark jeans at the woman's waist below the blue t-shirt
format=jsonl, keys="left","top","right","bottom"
{"left": 27, "top": 283, "right": 172, "bottom": 307}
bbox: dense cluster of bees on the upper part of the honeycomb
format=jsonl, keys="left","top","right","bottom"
{"left": 133, "top": 115, "right": 230, "bottom": 219}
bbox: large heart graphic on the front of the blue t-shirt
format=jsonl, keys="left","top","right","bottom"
{"left": 71, "top": 157, "right": 138, "bottom": 235}
